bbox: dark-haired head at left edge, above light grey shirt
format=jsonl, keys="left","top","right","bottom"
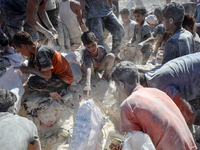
{"left": 0, "top": 89, "right": 17, "bottom": 112}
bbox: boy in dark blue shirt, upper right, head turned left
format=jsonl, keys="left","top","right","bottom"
{"left": 162, "top": 2, "right": 194, "bottom": 64}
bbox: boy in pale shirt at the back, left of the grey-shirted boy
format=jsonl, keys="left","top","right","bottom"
{"left": 119, "top": 8, "right": 136, "bottom": 42}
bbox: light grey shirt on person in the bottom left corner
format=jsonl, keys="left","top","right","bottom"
{"left": 0, "top": 112, "right": 39, "bottom": 150}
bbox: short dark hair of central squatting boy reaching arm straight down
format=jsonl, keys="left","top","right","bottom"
{"left": 81, "top": 31, "right": 97, "bottom": 45}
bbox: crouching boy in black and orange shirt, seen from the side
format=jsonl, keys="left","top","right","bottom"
{"left": 13, "top": 31, "right": 73, "bottom": 98}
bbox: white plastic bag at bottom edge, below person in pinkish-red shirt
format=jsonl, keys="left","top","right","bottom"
{"left": 122, "top": 131, "right": 155, "bottom": 150}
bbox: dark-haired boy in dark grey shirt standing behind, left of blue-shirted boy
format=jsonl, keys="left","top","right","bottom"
{"left": 131, "top": 6, "right": 152, "bottom": 65}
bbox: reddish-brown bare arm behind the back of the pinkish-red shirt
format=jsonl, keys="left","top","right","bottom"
{"left": 174, "top": 93, "right": 196, "bottom": 127}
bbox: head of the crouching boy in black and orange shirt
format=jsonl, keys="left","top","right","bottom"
{"left": 12, "top": 31, "right": 34, "bottom": 57}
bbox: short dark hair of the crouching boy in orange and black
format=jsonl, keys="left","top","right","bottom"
{"left": 12, "top": 31, "right": 34, "bottom": 48}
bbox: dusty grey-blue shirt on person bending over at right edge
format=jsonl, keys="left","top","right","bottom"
{"left": 145, "top": 53, "right": 200, "bottom": 101}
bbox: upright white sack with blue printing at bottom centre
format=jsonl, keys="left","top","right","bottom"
{"left": 68, "top": 100, "right": 105, "bottom": 150}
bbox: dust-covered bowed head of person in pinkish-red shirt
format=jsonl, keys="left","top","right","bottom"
{"left": 111, "top": 61, "right": 139, "bottom": 97}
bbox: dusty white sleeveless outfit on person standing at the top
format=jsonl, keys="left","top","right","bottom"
{"left": 59, "top": 0, "right": 82, "bottom": 44}
